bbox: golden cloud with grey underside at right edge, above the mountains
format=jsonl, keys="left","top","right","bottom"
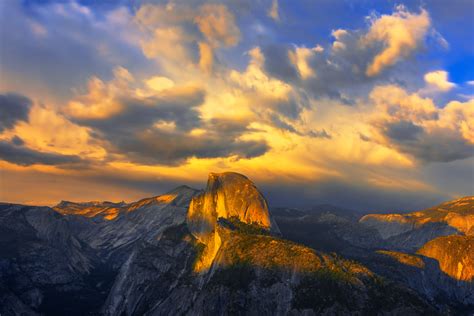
{"left": 370, "top": 85, "right": 474, "bottom": 162}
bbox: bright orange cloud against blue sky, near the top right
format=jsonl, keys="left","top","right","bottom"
{"left": 361, "top": 6, "right": 431, "bottom": 76}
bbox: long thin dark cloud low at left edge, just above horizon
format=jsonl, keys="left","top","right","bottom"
{"left": 0, "top": 136, "right": 82, "bottom": 166}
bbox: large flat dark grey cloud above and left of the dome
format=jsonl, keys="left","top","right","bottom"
{"left": 73, "top": 89, "right": 269, "bottom": 165}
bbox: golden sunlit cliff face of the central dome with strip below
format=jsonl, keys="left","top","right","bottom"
{"left": 186, "top": 172, "right": 277, "bottom": 271}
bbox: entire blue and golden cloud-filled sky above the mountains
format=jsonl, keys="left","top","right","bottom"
{"left": 0, "top": 0, "right": 474, "bottom": 210}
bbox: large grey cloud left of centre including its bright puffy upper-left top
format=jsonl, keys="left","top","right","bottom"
{"left": 68, "top": 69, "right": 269, "bottom": 165}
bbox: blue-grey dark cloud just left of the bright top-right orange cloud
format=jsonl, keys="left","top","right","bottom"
{"left": 256, "top": 31, "right": 390, "bottom": 105}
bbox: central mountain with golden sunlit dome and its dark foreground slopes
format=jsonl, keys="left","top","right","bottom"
{"left": 103, "top": 173, "right": 436, "bottom": 315}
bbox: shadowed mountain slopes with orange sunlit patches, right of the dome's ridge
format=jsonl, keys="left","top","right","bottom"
{"left": 272, "top": 197, "right": 474, "bottom": 315}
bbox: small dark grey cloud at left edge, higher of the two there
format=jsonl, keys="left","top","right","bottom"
{"left": 0, "top": 93, "right": 32, "bottom": 132}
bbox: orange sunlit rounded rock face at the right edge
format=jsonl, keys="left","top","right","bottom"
{"left": 418, "top": 235, "right": 474, "bottom": 282}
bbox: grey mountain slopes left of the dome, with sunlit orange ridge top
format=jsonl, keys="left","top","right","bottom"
{"left": 0, "top": 186, "right": 198, "bottom": 315}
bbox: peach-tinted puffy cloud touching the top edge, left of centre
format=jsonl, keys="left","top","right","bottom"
{"left": 135, "top": 2, "right": 240, "bottom": 72}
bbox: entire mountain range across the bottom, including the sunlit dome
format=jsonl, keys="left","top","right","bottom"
{"left": 0, "top": 173, "right": 474, "bottom": 316}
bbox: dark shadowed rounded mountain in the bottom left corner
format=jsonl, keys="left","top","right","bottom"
{"left": 0, "top": 204, "right": 100, "bottom": 315}
